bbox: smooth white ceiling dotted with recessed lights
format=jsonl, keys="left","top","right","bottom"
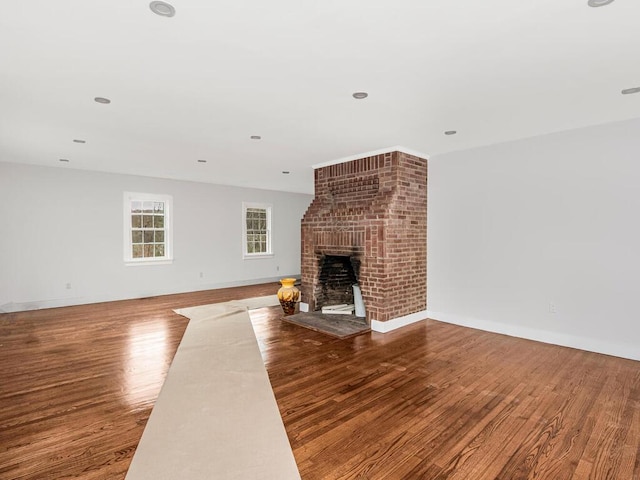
{"left": 0, "top": 0, "right": 640, "bottom": 193}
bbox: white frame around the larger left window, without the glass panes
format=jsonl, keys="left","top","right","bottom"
{"left": 122, "top": 192, "right": 173, "bottom": 265}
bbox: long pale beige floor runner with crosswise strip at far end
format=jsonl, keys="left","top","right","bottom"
{"left": 126, "top": 296, "right": 300, "bottom": 480}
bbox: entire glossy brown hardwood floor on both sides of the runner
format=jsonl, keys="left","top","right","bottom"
{"left": 0, "top": 284, "right": 640, "bottom": 480}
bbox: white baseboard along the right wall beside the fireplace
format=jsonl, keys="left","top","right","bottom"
{"left": 424, "top": 311, "right": 640, "bottom": 360}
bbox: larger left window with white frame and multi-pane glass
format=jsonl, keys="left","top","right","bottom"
{"left": 124, "top": 192, "right": 173, "bottom": 265}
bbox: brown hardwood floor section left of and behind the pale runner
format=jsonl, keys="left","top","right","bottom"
{"left": 0, "top": 283, "right": 278, "bottom": 480}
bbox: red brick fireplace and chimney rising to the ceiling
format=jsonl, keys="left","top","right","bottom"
{"left": 301, "top": 151, "right": 427, "bottom": 323}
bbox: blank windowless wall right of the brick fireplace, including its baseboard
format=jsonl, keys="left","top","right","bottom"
{"left": 427, "top": 119, "right": 640, "bottom": 360}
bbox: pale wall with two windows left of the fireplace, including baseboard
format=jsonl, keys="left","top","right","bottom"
{"left": 0, "top": 163, "right": 312, "bottom": 311}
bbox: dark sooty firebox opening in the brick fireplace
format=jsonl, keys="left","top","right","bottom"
{"left": 315, "top": 255, "right": 360, "bottom": 310}
